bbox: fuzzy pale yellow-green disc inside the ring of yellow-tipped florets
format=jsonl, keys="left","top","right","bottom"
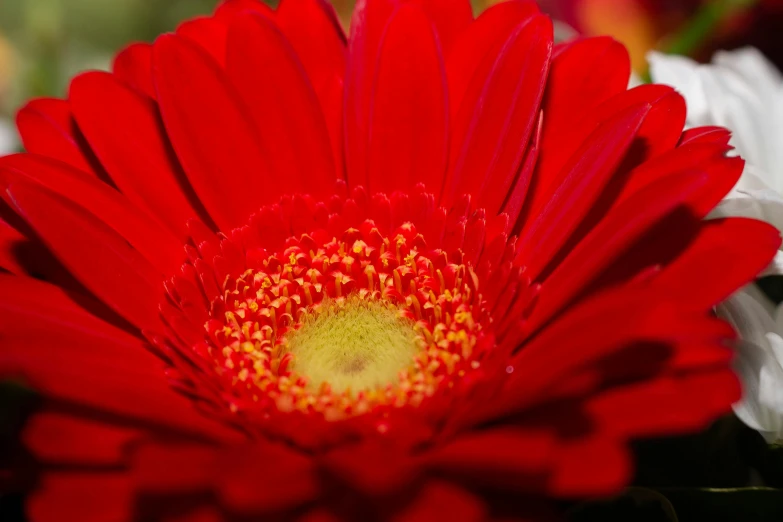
{"left": 284, "top": 295, "right": 423, "bottom": 392}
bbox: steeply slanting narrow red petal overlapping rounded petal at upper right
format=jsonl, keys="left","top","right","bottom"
{"left": 517, "top": 104, "right": 650, "bottom": 280}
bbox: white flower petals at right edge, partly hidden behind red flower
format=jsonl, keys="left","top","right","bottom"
{"left": 648, "top": 48, "right": 783, "bottom": 441}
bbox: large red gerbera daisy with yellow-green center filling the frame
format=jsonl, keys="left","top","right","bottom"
{"left": 0, "top": 0, "right": 780, "bottom": 521}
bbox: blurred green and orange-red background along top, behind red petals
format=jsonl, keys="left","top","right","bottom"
{"left": 0, "top": 0, "right": 783, "bottom": 148}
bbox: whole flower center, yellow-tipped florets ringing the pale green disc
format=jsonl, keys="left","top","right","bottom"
{"left": 199, "top": 220, "right": 492, "bottom": 420}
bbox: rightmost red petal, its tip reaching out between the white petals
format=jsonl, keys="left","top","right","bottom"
{"left": 650, "top": 218, "right": 781, "bottom": 309}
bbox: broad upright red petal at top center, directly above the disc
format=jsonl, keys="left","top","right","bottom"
{"left": 368, "top": 4, "right": 448, "bottom": 193}
